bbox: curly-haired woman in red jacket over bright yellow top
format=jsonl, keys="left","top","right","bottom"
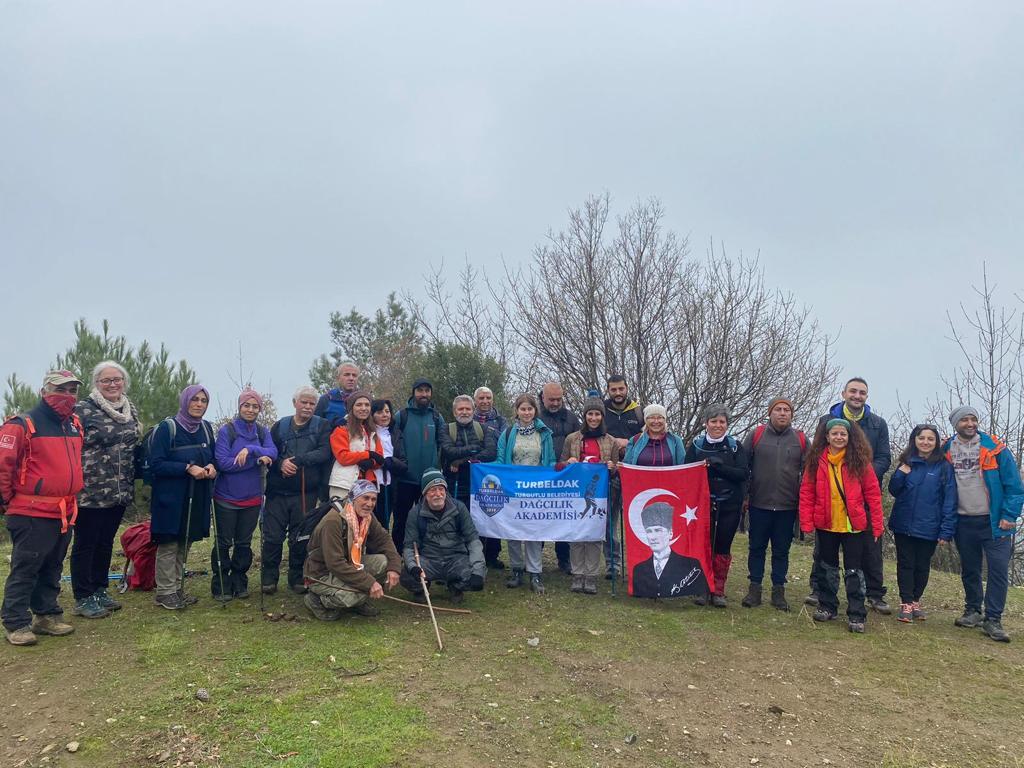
{"left": 800, "top": 419, "right": 884, "bottom": 632}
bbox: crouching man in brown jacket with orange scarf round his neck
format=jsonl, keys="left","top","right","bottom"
{"left": 303, "top": 480, "right": 401, "bottom": 622}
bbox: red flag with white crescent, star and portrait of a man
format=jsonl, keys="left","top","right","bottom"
{"left": 618, "top": 462, "right": 713, "bottom": 597}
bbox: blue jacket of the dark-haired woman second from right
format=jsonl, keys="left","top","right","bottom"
{"left": 889, "top": 456, "right": 956, "bottom": 542}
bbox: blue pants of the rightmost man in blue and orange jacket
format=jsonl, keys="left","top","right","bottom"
{"left": 956, "top": 515, "right": 1013, "bottom": 622}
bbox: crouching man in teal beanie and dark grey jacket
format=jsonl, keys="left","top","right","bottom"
{"left": 401, "top": 469, "right": 487, "bottom": 603}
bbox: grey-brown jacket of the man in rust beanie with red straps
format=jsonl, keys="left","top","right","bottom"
{"left": 743, "top": 424, "right": 804, "bottom": 511}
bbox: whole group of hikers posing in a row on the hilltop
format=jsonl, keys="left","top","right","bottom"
{"left": 0, "top": 360, "right": 1024, "bottom": 645}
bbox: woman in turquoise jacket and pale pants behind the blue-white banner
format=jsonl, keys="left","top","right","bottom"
{"left": 497, "top": 394, "right": 555, "bottom": 595}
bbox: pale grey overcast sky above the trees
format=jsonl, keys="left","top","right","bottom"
{"left": 0, "top": 0, "right": 1024, "bottom": 415}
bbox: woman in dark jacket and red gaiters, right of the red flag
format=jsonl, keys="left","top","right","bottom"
{"left": 686, "top": 404, "right": 750, "bottom": 608}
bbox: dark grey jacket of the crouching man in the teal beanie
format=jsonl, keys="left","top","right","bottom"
{"left": 401, "top": 495, "right": 487, "bottom": 577}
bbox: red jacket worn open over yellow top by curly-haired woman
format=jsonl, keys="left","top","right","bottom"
{"left": 800, "top": 452, "right": 885, "bottom": 537}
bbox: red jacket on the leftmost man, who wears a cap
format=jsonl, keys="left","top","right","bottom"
{"left": 0, "top": 401, "right": 83, "bottom": 532}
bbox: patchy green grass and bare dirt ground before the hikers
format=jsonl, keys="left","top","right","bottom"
{"left": 0, "top": 536, "right": 1024, "bottom": 768}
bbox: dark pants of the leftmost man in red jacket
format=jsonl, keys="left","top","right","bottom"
{"left": 0, "top": 515, "right": 71, "bottom": 632}
